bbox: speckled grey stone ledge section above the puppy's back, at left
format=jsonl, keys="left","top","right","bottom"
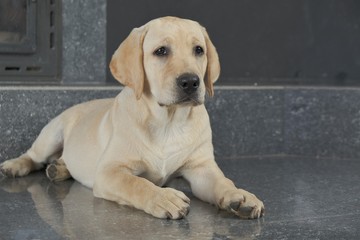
{"left": 0, "top": 87, "right": 121, "bottom": 162}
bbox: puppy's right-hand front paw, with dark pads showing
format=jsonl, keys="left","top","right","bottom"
{"left": 219, "top": 189, "right": 265, "bottom": 219}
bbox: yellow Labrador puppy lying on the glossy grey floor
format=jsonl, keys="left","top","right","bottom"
{"left": 1, "top": 17, "right": 264, "bottom": 219}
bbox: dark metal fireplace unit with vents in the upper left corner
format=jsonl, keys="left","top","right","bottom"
{"left": 0, "top": 0, "right": 61, "bottom": 84}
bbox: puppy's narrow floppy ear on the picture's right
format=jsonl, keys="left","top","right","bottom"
{"left": 202, "top": 28, "right": 220, "bottom": 97}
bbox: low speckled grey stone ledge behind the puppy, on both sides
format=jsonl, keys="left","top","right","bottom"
{"left": 0, "top": 87, "right": 360, "bottom": 161}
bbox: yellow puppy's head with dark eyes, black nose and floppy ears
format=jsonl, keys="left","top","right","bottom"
{"left": 110, "top": 17, "right": 220, "bottom": 106}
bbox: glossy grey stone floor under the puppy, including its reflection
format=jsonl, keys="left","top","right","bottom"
{"left": 0, "top": 156, "right": 360, "bottom": 240}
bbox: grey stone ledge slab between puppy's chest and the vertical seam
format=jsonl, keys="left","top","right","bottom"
{"left": 206, "top": 88, "right": 284, "bottom": 157}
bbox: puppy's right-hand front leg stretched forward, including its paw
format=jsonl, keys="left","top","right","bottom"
{"left": 183, "top": 160, "right": 264, "bottom": 219}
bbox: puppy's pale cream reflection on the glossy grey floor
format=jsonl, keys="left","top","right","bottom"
{"left": 0, "top": 173, "right": 261, "bottom": 239}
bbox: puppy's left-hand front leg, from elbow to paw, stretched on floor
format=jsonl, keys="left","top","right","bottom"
{"left": 93, "top": 163, "right": 190, "bottom": 219}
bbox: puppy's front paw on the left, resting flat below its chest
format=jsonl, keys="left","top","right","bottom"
{"left": 145, "top": 188, "right": 190, "bottom": 219}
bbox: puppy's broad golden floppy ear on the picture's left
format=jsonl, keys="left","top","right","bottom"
{"left": 110, "top": 26, "right": 147, "bottom": 99}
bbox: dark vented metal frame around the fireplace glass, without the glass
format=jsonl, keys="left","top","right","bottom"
{"left": 0, "top": 0, "right": 62, "bottom": 85}
